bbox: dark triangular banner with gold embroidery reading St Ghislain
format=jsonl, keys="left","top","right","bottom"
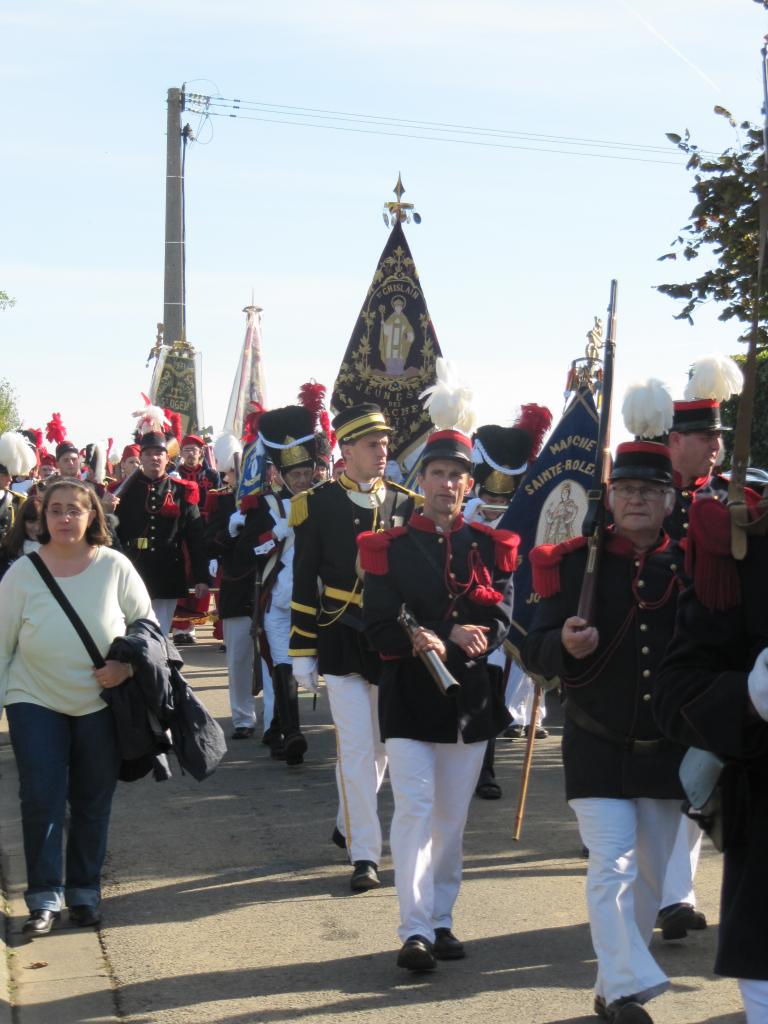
{"left": 331, "top": 221, "right": 441, "bottom": 466}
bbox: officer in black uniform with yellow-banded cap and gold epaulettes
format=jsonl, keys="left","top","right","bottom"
{"left": 288, "top": 403, "right": 414, "bottom": 892}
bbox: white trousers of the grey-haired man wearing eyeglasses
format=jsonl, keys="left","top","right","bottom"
{"left": 569, "top": 798, "right": 680, "bottom": 1004}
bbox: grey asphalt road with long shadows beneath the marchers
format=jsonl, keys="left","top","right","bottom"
{"left": 0, "top": 634, "right": 743, "bottom": 1024}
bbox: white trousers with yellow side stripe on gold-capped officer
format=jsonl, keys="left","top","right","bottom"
{"left": 326, "top": 673, "right": 387, "bottom": 864}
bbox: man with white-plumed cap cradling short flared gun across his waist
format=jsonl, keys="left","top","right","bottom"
{"left": 359, "top": 430, "right": 518, "bottom": 971}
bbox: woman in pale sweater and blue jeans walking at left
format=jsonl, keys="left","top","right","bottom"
{"left": 0, "top": 479, "right": 154, "bottom": 935}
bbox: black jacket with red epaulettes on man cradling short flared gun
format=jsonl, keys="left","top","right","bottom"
{"left": 360, "top": 513, "right": 519, "bottom": 743}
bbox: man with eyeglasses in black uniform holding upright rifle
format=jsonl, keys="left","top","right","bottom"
{"left": 522, "top": 441, "right": 683, "bottom": 1024}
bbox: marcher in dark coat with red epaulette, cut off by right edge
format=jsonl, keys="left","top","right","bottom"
{"left": 653, "top": 491, "right": 768, "bottom": 1024}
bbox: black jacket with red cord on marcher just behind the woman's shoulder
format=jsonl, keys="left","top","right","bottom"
{"left": 118, "top": 473, "right": 210, "bottom": 598}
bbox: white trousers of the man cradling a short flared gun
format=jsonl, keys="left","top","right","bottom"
{"left": 385, "top": 737, "right": 487, "bottom": 942}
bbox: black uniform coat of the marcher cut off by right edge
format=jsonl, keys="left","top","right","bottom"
{"left": 653, "top": 532, "right": 768, "bottom": 981}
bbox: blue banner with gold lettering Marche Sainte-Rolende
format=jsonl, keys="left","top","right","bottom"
{"left": 499, "top": 388, "right": 598, "bottom": 656}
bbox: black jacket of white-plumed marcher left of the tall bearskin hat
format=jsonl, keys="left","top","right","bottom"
{"left": 204, "top": 487, "right": 264, "bottom": 618}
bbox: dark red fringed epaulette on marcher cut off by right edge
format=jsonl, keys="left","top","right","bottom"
{"left": 685, "top": 498, "right": 741, "bottom": 611}
